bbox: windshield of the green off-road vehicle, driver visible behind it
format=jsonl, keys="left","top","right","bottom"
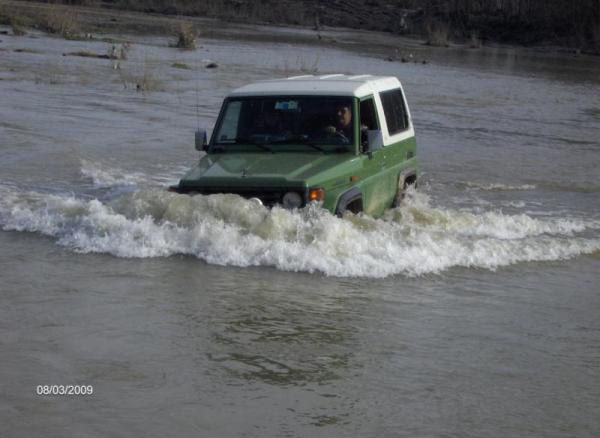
{"left": 213, "top": 96, "right": 354, "bottom": 152}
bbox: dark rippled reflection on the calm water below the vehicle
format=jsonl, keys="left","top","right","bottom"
{"left": 208, "top": 303, "right": 353, "bottom": 386}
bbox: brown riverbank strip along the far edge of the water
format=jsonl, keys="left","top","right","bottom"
{"left": 0, "top": 0, "right": 600, "bottom": 56}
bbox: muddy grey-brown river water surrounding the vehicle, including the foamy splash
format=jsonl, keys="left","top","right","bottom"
{"left": 0, "top": 23, "right": 600, "bottom": 438}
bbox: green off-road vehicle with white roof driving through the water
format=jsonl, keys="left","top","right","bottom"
{"left": 171, "top": 74, "right": 417, "bottom": 216}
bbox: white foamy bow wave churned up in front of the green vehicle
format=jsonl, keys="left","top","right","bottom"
{"left": 0, "top": 186, "right": 600, "bottom": 277}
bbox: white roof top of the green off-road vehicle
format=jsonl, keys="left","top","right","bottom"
{"left": 229, "top": 74, "right": 401, "bottom": 97}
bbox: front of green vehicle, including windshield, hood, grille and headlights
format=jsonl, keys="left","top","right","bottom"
{"left": 176, "top": 96, "right": 356, "bottom": 208}
